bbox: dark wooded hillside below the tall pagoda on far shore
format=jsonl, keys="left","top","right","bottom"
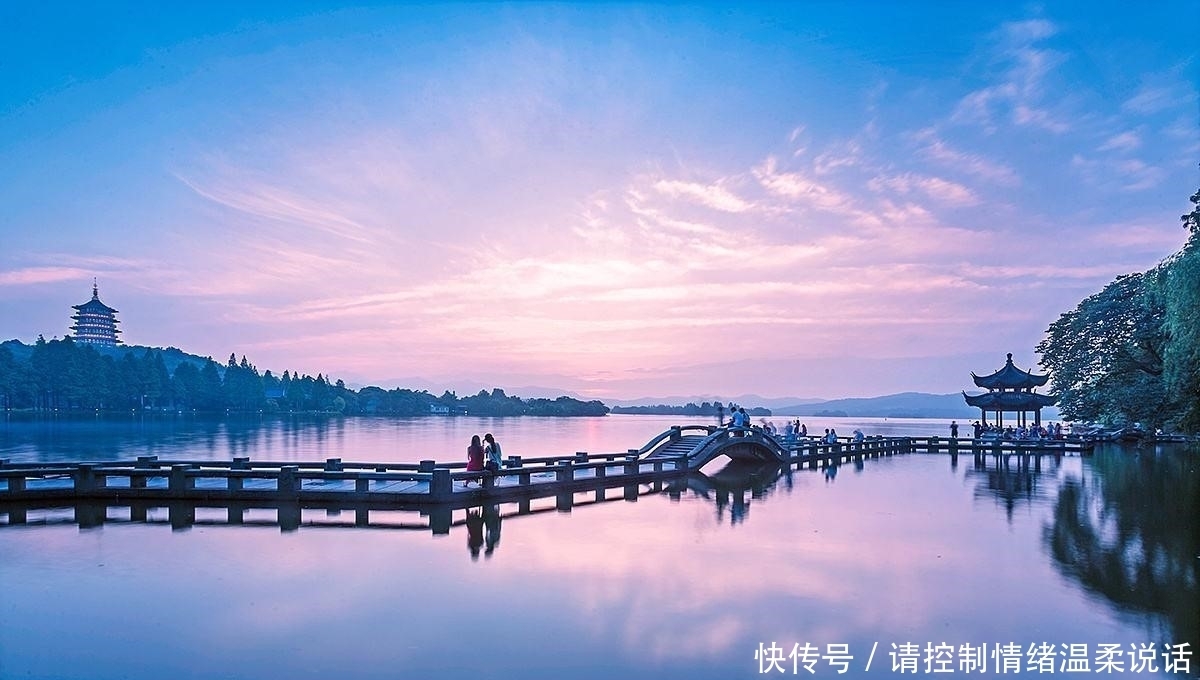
{"left": 0, "top": 337, "right": 608, "bottom": 416}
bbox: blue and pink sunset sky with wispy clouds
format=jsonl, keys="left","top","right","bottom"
{"left": 0, "top": 1, "right": 1200, "bottom": 399}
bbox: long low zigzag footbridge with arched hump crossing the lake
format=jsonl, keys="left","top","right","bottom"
{"left": 0, "top": 425, "right": 1091, "bottom": 511}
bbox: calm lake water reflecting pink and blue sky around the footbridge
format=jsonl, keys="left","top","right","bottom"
{"left": 0, "top": 416, "right": 1200, "bottom": 680}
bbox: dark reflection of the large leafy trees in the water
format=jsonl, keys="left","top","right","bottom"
{"left": 1043, "top": 446, "right": 1200, "bottom": 676}
